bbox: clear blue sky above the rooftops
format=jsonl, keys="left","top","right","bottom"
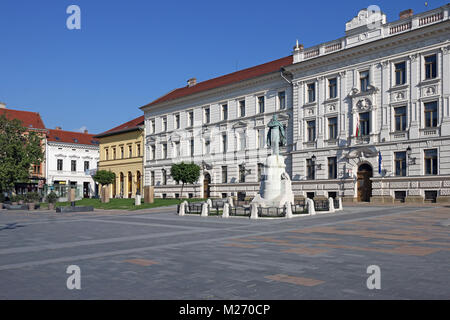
{"left": 0, "top": 0, "right": 448, "bottom": 133}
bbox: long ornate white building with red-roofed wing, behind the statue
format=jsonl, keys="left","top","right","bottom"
{"left": 142, "top": 5, "right": 450, "bottom": 202}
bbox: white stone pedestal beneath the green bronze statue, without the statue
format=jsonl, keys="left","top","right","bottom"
{"left": 252, "top": 155, "right": 294, "bottom": 208}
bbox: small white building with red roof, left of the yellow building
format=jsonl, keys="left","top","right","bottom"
{"left": 45, "top": 128, "right": 99, "bottom": 199}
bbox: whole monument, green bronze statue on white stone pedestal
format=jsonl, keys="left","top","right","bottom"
{"left": 252, "top": 115, "right": 294, "bottom": 208}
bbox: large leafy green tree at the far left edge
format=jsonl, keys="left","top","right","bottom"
{"left": 0, "top": 114, "right": 44, "bottom": 192}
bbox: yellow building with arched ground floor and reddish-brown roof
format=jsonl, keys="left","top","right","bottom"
{"left": 95, "top": 116, "right": 144, "bottom": 198}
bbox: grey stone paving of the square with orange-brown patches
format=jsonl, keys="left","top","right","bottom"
{"left": 0, "top": 205, "right": 450, "bottom": 300}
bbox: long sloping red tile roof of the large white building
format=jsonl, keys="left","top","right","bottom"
{"left": 144, "top": 56, "right": 293, "bottom": 107}
